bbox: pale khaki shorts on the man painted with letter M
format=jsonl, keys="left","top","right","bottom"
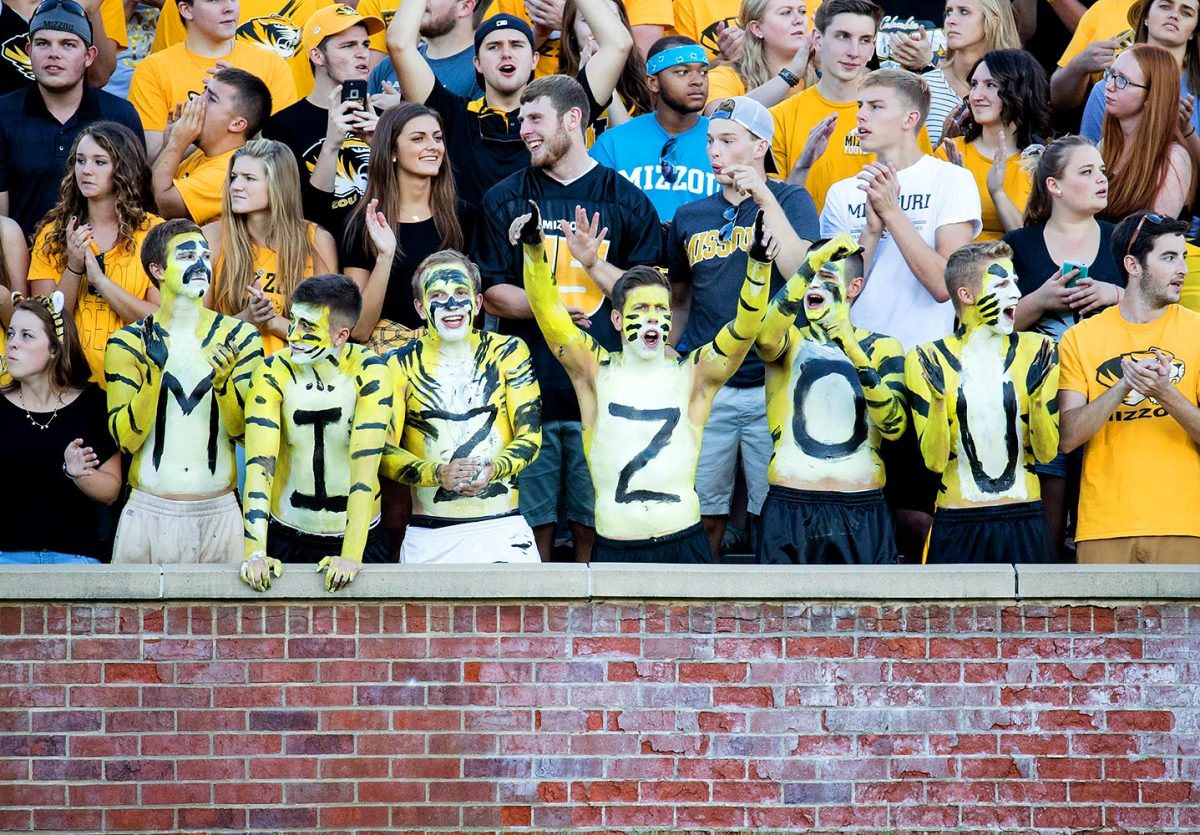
{"left": 113, "top": 489, "right": 242, "bottom": 565}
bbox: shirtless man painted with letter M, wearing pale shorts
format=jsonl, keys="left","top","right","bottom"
{"left": 104, "top": 220, "right": 263, "bottom": 563}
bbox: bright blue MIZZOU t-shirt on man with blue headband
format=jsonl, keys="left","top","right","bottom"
{"left": 592, "top": 113, "right": 721, "bottom": 223}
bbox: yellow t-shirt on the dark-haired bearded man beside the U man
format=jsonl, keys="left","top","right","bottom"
{"left": 1058, "top": 305, "right": 1200, "bottom": 542}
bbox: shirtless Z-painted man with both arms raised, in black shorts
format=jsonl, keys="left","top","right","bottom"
{"left": 509, "top": 202, "right": 779, "bottom": 563}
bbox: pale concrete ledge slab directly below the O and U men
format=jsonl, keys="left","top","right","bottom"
{"left": 590, "top": 564, "right": 1015, "bottom": 600}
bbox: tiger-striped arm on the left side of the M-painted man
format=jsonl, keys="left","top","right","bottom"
{"left": 104, "top": 316, "right": 167, "bottom": 453}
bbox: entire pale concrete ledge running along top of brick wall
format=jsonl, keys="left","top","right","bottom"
{"left": 7, "top": 563, "right": 1200, "bottom": 602}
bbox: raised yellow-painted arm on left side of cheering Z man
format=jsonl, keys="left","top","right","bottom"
{"left": 509, "top": 200, "right": 607, "bottom": 386}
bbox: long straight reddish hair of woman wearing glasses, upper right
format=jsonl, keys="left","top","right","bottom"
{"left": 1100, "top": 43, "right": 1190, "bottom": 221}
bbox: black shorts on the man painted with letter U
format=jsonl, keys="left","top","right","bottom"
{"left": 925, "top": 501, "right": 1054, "bottom": 564}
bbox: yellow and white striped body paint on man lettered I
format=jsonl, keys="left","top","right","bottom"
{"left": 242, "top": 326, "right": 392, "bottom": 561}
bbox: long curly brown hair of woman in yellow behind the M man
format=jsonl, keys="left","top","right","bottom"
{"left": 28, "top": 121, "right": 155, "bottom": 264}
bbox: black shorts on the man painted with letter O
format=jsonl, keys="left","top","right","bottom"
{"left": 757, "top": 486, "right": 896, "bottom": 565}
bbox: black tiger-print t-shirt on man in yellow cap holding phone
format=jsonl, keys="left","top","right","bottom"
{"left": 263, "top": 98, "right": 371, "bottom": 239}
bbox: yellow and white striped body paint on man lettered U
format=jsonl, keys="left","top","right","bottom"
{"left": 905, "top": 259, "right": 1058, "bottom": 507}
